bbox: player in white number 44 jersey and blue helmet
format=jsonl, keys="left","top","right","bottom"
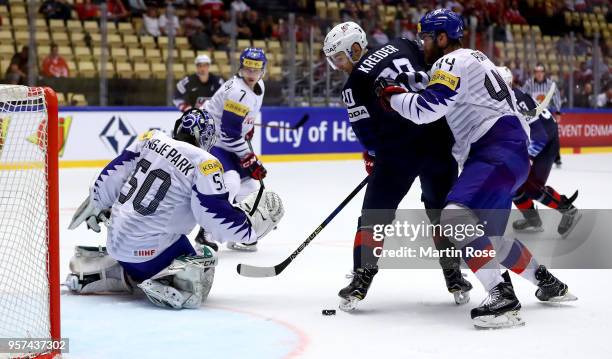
{"left": 376, "top": 9, "right": 576, "bottom": 328}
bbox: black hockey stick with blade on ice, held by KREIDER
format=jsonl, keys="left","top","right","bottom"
{"left": 236, "top": 177, "right": 368, "bottom": 278}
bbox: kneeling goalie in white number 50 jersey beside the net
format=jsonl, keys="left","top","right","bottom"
{"left": 66, "top": 109, "right": 284, "bottom": 309}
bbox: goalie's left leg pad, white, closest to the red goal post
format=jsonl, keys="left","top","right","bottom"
{"left": 65, "top": 246, "right": 132, "bottom": 294}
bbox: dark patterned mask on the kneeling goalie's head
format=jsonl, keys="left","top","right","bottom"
{"left": 172, "top": 108, "right": 217, "bottom": 151}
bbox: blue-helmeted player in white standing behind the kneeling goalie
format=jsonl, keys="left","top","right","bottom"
{"left": 204, "top": 48, "right": 267, "bottom": 251}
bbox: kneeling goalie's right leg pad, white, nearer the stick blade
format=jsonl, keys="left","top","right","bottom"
{"left": 138, "top": 246, "right": 217, "bottom": 309}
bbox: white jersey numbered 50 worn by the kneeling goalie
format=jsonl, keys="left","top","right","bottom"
{"left": 92, "top": 130, "right": 257, "bottom": 263}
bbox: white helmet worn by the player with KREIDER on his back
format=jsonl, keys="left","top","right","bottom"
{"left": 323, "top": 21, "right": 368, "bottom": 70}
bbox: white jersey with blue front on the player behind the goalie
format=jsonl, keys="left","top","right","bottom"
{"left": 204, "top": 76, "right": 265, "bottom": 158}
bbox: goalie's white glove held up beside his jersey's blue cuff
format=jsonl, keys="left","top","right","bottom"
{"left": 238, "top": 189, "right": 285, "bottom": 240}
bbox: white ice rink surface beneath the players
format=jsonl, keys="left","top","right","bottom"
{"left": 60, "top": 154, "right": 612, "bottom": 359}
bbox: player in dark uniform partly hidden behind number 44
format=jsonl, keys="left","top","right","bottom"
{"left": 497, "top": 66, "right": 580, "bottom": 237}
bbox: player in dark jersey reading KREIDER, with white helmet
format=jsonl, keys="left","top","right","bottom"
{"left": 323, "top": 22, "right": 472, "bottom": 310}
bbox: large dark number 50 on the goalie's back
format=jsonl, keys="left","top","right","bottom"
{"left": 119, "top": 158, "right": 172, "bottom": 216}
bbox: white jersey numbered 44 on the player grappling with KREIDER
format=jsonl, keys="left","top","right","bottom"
{"left": 391, "top": 49, "right": 529, "bottom": 165}
